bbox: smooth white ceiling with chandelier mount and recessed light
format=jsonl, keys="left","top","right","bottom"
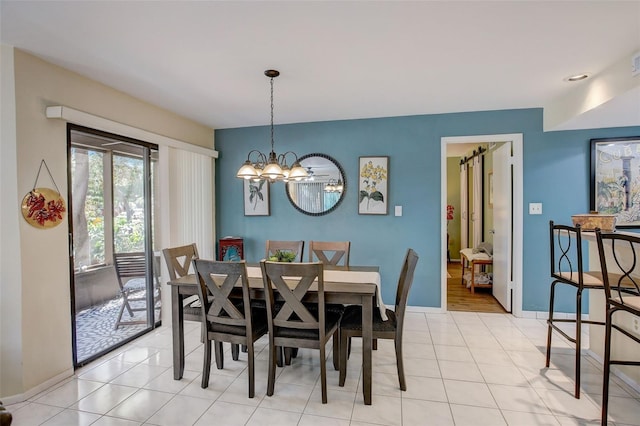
{"left": 0, "top": 0, "right": 640, "bottom": 129}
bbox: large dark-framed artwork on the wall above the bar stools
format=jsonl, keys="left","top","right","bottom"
{"left": 590, "top": 136, "right": 640, "bottom": 228}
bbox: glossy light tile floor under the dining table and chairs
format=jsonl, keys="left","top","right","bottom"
{"left": 8, "top": 312, "right": 640, "bottom": 426}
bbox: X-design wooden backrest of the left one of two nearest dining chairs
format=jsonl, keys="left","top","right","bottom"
{"left": 193, "top": 259, "right": 251, "bottom": 328}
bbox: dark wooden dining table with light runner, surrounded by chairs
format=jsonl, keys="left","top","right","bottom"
{"left": 167, "top": 264, "right": 386, "bottom": 405}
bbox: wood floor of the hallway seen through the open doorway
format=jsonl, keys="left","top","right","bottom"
{"left": 447, "top": 262, "right": 505, "bottom": 313}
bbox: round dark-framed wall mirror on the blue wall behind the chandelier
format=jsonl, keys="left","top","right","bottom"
{"left": 286, "top": 153, "right": 347, "bottom": 216}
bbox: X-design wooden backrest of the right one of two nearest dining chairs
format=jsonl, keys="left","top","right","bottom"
{"left": 260, "top": 261, "right": 325, "bottom": 334}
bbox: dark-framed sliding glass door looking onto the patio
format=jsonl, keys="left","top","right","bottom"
{"left": 68, "top": 125, "right": 161, "bottom": 366}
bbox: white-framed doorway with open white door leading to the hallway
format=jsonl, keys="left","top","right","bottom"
{"left": 441, "top": 134, "right": 523, "bottom": 316}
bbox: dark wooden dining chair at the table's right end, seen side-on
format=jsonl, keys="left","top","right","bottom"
{"left": 339, "top": 249, "right": 418, "bottom": 391}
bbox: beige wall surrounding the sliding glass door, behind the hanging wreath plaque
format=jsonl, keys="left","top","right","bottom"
{"left": 0, "top": 47, "right": 214, "bottom": 397}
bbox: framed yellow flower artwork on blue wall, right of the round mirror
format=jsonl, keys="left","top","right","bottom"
{"left": 358, "top": 156, "right": 389, "bottom": 215}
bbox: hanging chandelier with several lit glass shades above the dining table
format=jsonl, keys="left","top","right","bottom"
{"left": 236, "top": 70, "right": 308, "bottom": 182}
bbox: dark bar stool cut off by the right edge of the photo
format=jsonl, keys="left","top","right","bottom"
{"left": 596, "top": 229, "right": 640, "bottom": 425}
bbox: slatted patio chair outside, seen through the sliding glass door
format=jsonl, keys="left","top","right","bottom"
{"left": 113, "top": 252, "right": 160, "bottom": 330}
